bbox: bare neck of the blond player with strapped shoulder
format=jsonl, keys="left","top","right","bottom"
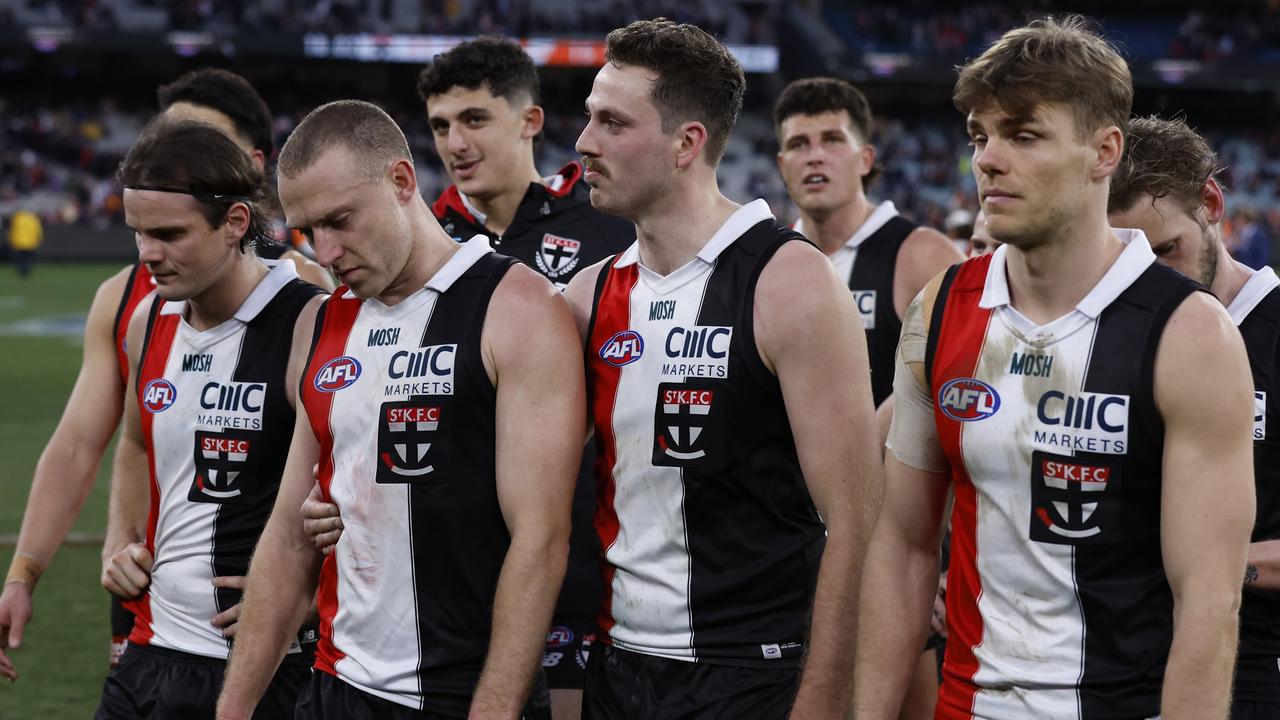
{"left": 1005, "top": 213, "right": 1125, "bottom": 325}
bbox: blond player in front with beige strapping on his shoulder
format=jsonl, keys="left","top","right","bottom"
{"left": 855, "top": 17, "right": 1254, "bottom": 720}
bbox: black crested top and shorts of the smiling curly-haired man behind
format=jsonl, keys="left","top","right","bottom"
{"left": 433, "top": 163, "right": 636, "bottom": 689}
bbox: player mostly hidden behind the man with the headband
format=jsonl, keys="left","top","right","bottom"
{"left": 0, "top": 68, "right": 333, "bottom": 680}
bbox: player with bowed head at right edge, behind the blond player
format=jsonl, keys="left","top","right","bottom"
{"left": 1108, "top": 117, "right": 1280, "bottom": 720}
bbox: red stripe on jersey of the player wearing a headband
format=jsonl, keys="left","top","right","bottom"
{"left": 124, "top": 297, "right": 182, "bottom": 644}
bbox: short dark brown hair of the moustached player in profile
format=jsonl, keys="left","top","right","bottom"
{"left": 604, "top": 18, "right": 746, "bottom": 167}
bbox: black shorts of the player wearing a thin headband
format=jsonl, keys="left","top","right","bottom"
{"left": 93, "top": 644, "right": 311, "bottom": 720}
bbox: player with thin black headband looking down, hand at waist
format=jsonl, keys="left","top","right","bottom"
{"left": 95, "top": 117, "right": 323, "bottom": 720}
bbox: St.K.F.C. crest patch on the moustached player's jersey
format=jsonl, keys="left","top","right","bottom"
{"left": 653, "top": 382, "right": 724, "bottom": 468}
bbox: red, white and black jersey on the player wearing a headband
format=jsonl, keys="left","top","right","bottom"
{"left": 125, "top": 263, "right": 320, "bottom": 659}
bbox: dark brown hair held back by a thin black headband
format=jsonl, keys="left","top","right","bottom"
{"left": 116, "top": 115, "right": 271, "bottom": 250}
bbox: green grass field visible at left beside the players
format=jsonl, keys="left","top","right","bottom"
{"left": 0, "top": 264, "right": 120, "bottom": 720}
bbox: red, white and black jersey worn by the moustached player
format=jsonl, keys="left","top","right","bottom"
{"left": 586, "top": 200, "right": 826, "bottom": 667}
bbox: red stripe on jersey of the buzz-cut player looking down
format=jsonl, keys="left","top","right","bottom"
{"left": 298, "top": 286, "right": 361, "bottom": 675}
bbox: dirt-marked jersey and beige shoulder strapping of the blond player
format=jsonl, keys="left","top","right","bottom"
{"left": 888, "top": 231, "right": 1202, "bottom": 720}
